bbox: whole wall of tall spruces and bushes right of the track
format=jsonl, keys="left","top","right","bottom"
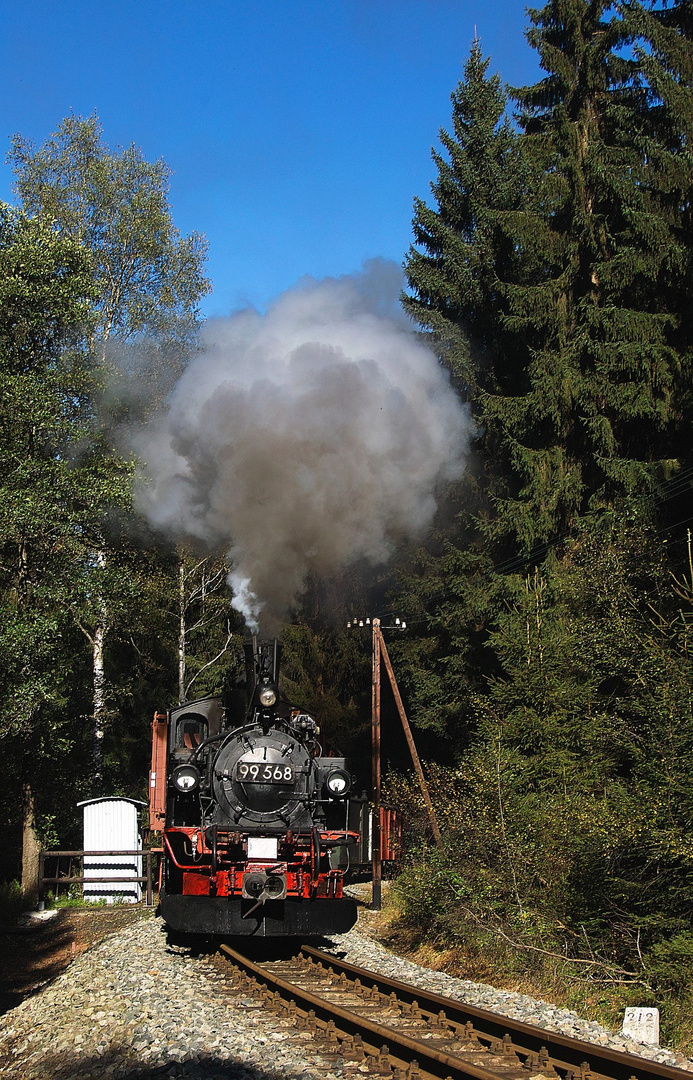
{"left": 389, "top": 10, "right": 693, "bottom": 1035}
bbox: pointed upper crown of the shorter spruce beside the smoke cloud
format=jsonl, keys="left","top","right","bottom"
{"left": 403, "top": 39, "right": 525, "bottom": 402}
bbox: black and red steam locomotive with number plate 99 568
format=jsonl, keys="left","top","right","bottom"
{"left": 150, "top": 638, "right": 358, "bottom": 941}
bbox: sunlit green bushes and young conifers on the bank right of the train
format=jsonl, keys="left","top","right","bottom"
{"left": 388, "top": 504, "right": 693, "bottom": 1025}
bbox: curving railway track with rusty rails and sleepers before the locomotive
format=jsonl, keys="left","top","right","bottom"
{"left": 220, "top": 945, "right": 687, "bottom": 1080}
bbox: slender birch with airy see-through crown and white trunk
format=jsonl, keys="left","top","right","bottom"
{"left": 9, "top": 114, "right": 209, "bottom": 787}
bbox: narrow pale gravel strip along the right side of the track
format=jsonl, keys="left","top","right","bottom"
{"left": 326, "top": 887, "right": 693, "bottom": 1071}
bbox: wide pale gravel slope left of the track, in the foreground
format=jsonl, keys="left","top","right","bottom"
{"left": 0, "top": 915, "right": 340, "bottom": 1080}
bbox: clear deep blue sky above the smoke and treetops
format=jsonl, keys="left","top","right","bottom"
{"left": 0, "top": 0, "right": 539, "bottom": 315}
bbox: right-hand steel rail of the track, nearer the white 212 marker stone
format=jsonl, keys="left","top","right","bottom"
{"left": 301, "top": 945, "right": 688, "bottom": 1080}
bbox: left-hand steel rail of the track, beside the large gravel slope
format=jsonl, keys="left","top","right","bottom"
{"left": 219, "top": 945, "right": 519, "bottom": 1080}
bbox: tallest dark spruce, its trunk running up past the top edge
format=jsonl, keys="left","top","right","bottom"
{"left": 483, "top": 0, "right": 679, "bottom": 550}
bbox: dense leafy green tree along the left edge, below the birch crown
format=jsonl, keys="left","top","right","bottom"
{"left": 0, "top": 207, "right": 118, "bottom": 855}
